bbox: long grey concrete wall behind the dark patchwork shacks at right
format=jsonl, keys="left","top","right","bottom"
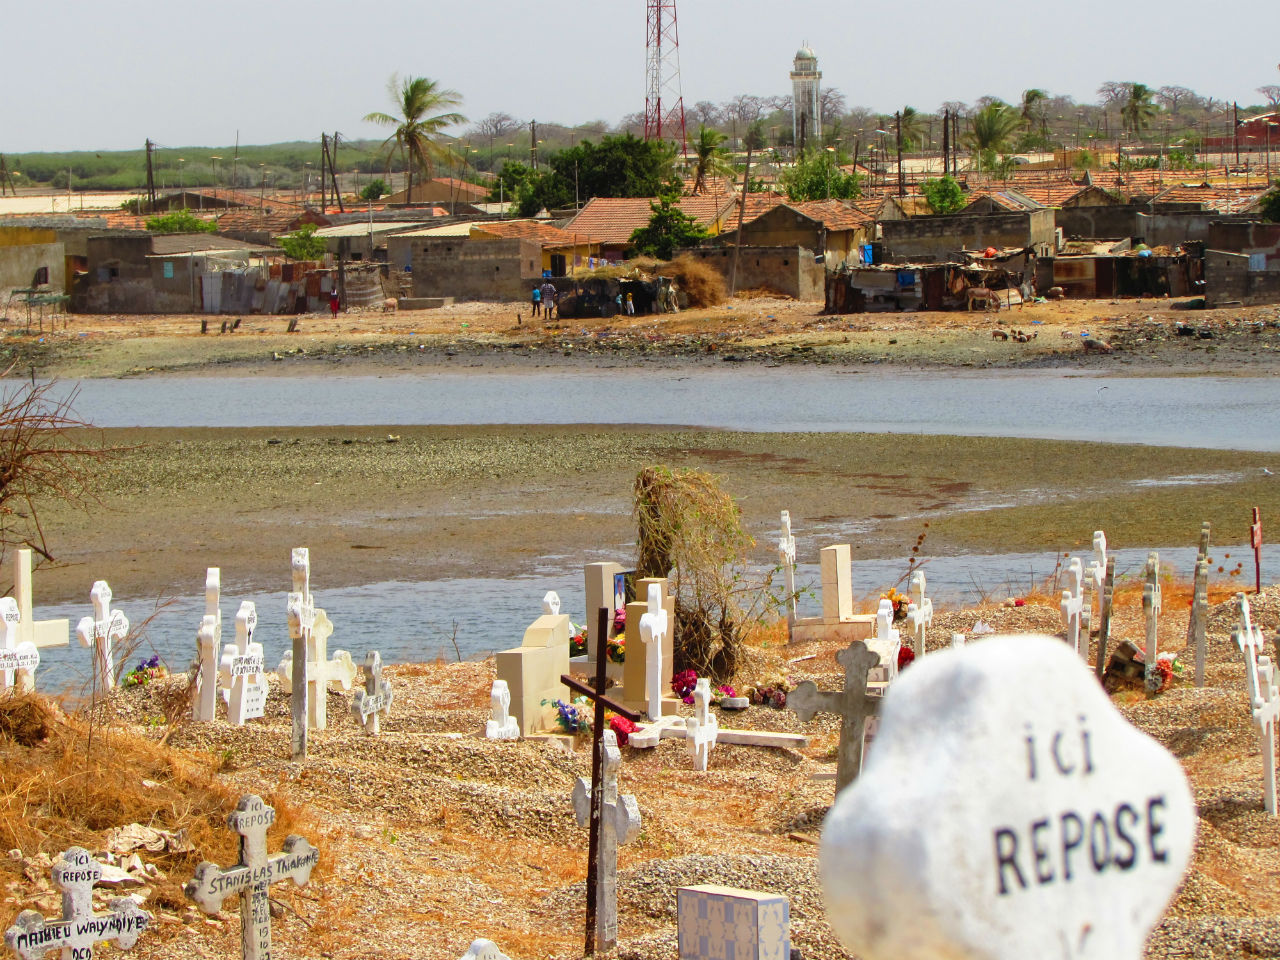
{"left": 881, "top": 209, "right": 1056, "bottom": 262}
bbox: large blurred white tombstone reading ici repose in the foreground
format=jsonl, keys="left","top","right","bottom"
{"left": 819, "top": 636, "right": 1196, "bottom": 960}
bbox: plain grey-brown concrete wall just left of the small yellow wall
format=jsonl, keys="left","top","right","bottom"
{"left": 410, "top": 237, "right": 543, "bottom": 301}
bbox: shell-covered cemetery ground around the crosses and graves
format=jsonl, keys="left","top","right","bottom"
{"left": 0, "top": 577, "right": 1280, "bottom": 960}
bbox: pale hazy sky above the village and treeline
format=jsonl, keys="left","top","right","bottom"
{"left": 0, "top": 0, "right": 1280, "bottom": 152}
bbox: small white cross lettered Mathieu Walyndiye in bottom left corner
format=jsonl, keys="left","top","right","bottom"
{"left": 4, "top": 846, "right": 151, "bottom": 960}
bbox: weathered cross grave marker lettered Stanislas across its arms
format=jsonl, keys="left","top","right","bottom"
{"left": 183, "top": 794, "right": 320, "bottom": 960}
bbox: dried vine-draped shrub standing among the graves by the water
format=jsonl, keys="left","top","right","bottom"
{"left": 635, "top": 466, "right": 754, "bottom": 682}
